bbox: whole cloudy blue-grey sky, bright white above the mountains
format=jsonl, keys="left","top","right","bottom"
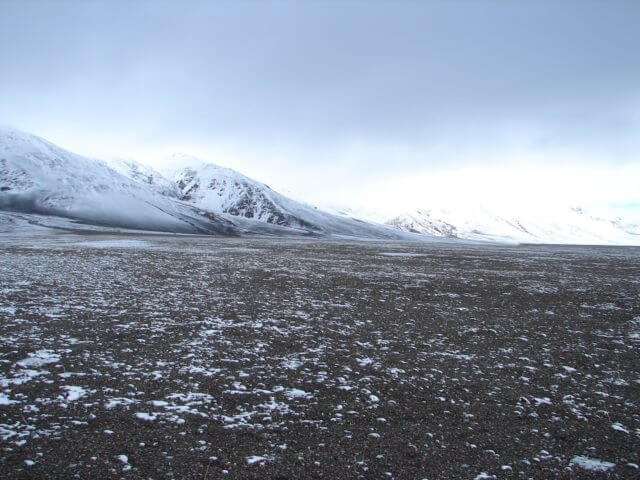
{"left": 0, "top": 0, "right": 640, "bottom": 218}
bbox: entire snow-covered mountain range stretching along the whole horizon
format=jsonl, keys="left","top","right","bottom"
{"left": 0, "top": 128, "right": 640, "bottom": 245}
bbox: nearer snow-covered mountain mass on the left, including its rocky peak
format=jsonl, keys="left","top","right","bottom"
{"left": 0, "top": 128, "right": 416, "bottom": 239}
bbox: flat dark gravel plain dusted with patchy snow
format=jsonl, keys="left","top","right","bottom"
{"left": 0, "top": 234, "right": 640, "bottom": 480}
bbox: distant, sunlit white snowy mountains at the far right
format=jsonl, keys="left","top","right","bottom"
{"left": 386, "top": 206, "right": 640, "bottom": 245}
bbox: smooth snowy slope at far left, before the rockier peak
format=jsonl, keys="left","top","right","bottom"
{"left": 0, "top": 128, "right": 238, "bottom": 233}
